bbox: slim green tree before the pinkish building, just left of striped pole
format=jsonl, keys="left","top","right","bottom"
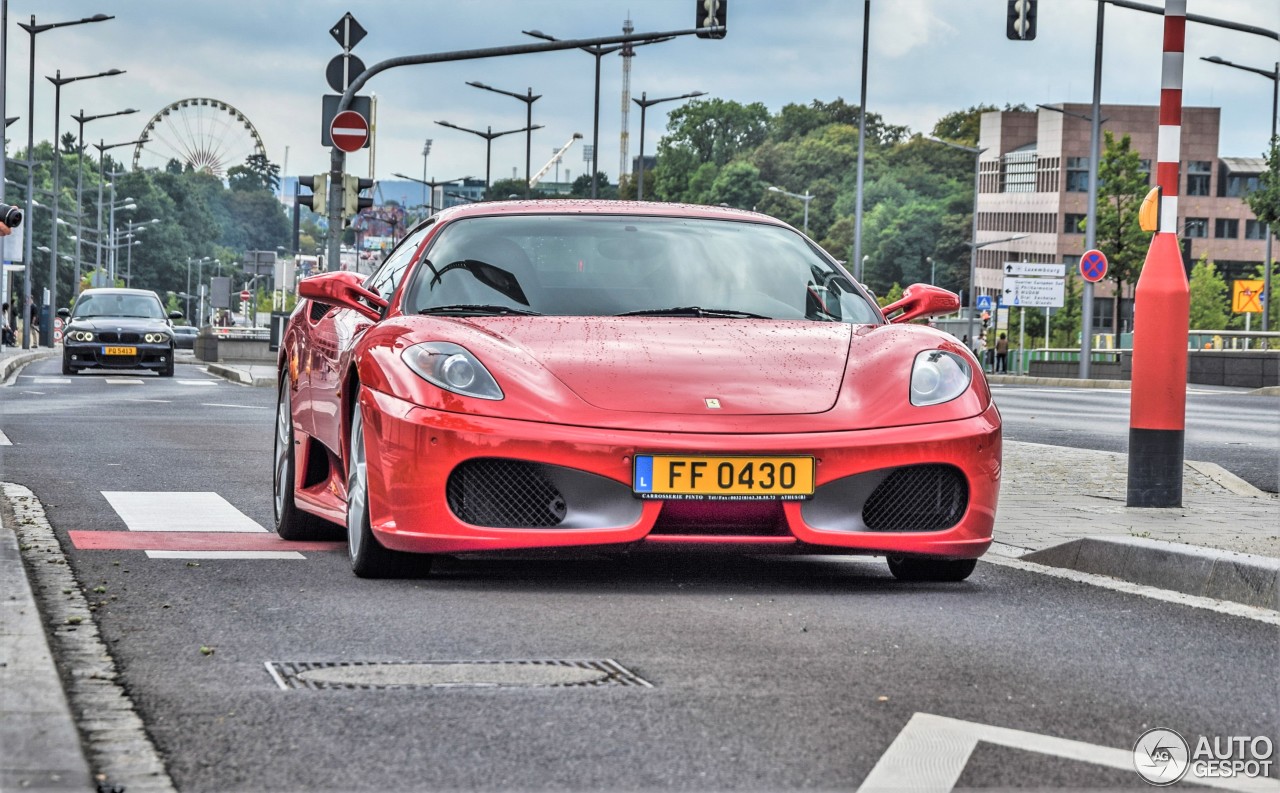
{"left": 1097, "top": 132, "right": 1151, "bottom": 329}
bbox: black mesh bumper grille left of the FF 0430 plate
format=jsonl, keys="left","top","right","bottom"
{"left": 445, "top": 458, "right": 567, "bottom": 528}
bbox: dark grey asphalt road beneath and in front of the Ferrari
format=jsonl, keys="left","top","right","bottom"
{"left": 0, "top": 361, "right": 1280, "bottom": 792}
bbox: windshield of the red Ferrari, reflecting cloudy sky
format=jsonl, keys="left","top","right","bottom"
{"left": 403, "top": 215, "right": 879, "bottom": 324}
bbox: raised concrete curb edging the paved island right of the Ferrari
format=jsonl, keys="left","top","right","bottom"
{"left": 1020, "top": 537, "right": 1280, "bottom": 609}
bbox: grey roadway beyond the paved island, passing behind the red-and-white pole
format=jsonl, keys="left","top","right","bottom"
{"left": 992, "top": 385, "right": 1280, "bottom": 492}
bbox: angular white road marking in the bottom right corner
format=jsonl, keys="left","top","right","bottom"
{"left": 858, "top": 712, "right": 1280, "bottom": 793}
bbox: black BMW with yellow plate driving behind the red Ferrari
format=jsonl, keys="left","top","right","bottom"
{"left": 58, "top": 289, "right": 182, "bottom": 377}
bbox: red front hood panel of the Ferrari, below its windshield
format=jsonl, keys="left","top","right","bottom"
{"left": 475, "top": 317, "right": 852, "bottom": 416}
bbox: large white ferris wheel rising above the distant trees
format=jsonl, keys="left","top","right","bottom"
{"left": 133, "top": 97, "right": 266, "bottom": 178}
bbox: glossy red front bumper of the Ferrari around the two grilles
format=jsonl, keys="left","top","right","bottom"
{"left": 361, "top": 389, "right": 1001, "bottom": 559}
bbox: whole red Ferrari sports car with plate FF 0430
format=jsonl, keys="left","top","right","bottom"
{"left": 274, "top": 201, "right": 1001, "bottom": 581}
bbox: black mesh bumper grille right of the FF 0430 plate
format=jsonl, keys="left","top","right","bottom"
{"left": 863, "top": 466, "right": 969, "bottom": 531}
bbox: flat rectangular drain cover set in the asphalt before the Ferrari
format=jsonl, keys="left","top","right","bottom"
{"left": 266, "top": 659, "right": 653, "bottom": 691}
